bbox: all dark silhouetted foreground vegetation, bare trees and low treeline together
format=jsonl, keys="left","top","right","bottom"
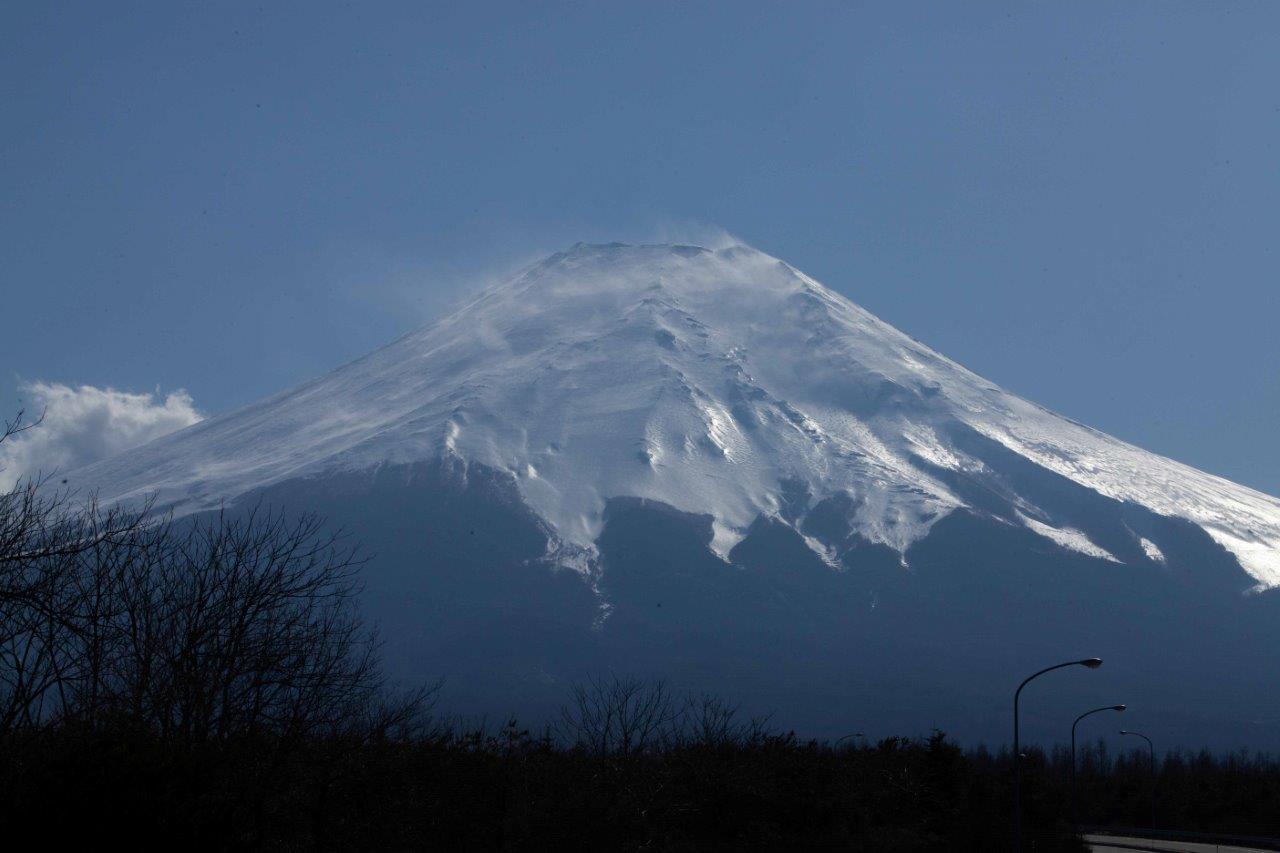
{"left": 0, "top": 412, "right": 1280, "bottom": 850}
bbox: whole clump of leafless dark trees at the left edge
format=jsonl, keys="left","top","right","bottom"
{"left": 0, "top": 415, "right": 434, "bottom": 743}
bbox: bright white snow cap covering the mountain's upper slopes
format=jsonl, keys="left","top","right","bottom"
{"left": 62, "top": 245, "right": 1280, "bottom": 587}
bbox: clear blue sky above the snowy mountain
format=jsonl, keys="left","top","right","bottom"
{"left": 0, "top": 3, "right": 1280, "bottom": 494}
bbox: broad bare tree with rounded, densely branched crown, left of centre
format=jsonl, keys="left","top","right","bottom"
{"left": 73, "top": 510, "right": 396, "bottom": 742}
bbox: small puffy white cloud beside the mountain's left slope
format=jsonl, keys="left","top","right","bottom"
{"left": 0, "top": 382, "right": 204, "bottom": 488}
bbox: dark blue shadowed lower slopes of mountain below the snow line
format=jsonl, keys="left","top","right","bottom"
{"left": 256, "top": 445, "right": 1280, "bottom": 748}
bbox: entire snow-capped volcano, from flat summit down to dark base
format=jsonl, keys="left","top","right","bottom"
{"left": 68, "top": 243, "right": 1280, "bottom": 745}
